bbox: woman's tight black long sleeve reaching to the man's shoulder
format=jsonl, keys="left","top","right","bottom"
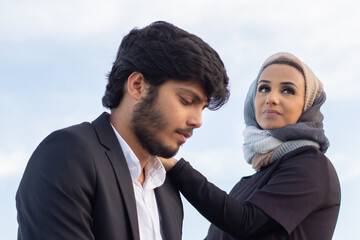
{"left": 168, "top": 159, "right": 281, "bottom": 238}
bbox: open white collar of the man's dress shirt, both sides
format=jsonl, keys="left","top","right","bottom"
{"left": 110, "top": 123, "right": 166, "bottom": 189}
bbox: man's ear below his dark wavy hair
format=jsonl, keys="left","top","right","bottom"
{"left": 127, "top": 72, "right": 147, "bottom": 101}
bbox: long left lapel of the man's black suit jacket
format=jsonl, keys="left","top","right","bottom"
{"left": 92, "top": 113, "right": 140, "bottom": 240}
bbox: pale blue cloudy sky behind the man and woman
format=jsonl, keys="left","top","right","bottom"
{"left": 0, "top": 0, "right": 360, "bottom": 240}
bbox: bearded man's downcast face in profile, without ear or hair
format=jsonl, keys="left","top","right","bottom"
{"left": 132, "top": 80, "right": 208, "bottom": 158}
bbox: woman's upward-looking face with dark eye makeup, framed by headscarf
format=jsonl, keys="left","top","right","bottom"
{"left": 255, "top": 64, "right": 305, "bottom": 130}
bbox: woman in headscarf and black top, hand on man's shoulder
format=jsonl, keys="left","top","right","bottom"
{"left": 162, "top": 53, "right": 340, "bottom": 240}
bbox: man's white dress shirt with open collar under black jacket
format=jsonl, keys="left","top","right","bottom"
{"left": 111, "top": 125, "right": 166, "bottom": 240}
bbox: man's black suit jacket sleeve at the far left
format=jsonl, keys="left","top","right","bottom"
{"left": 16, "top": 131, "right": 95, "bottom": 240}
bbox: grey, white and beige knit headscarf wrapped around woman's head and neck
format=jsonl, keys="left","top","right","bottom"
{"left": 243, "top": 52, "right": 329, "bottom": 170}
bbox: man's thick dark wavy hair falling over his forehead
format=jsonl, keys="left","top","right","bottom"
{"left": 102, "top": 21, "right": 230, "bottom": 110}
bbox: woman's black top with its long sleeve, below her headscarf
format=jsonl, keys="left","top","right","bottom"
{"left": 168, "top": 146, "right": 340, "bottom": 240}
